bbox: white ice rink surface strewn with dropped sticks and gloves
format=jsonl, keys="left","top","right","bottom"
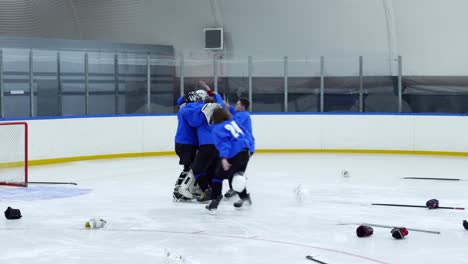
{"left": 0, "top": 154, "right": 468, "bottom": 264}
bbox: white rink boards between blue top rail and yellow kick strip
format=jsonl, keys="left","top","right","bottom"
{"left": 6, "top": 114, "right": 468, "bottom": 160}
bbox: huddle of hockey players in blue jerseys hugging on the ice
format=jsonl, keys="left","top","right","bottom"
{"left": 173, "top": 82, "right": 255, "bottom": 211}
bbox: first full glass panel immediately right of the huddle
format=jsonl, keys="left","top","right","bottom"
{"left": 252, "top": 58, "right": 284, "bottom": 112}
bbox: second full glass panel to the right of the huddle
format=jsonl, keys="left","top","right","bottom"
{"left": 288, "top": 58, "right": 320, "bottom": 112}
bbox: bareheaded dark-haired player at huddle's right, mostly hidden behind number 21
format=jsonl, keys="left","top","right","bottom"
{"left": 224, "top": 97, "right": 255, "bottom": 199}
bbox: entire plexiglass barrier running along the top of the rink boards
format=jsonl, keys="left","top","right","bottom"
{"left": 0, "top": 48, "right": 468, "bottom": 118}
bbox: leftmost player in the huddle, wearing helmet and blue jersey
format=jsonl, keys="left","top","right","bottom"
{"left": 173, "top": 92, "right": 201, "bottom": 201}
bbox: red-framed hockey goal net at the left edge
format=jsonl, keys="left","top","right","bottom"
{"left": 0, "top": 122, "right": 28, "bottom": 187}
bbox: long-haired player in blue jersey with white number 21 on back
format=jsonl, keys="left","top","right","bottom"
{"left": 206, "top": 107, "right": 253, "bottom": 211}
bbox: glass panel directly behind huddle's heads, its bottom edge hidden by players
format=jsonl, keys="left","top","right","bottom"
{"left": 218, "top": 57, "right": 249, "bottom": 108}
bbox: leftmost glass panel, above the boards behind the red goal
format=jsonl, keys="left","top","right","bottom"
{"left": 3, "top": 49, "right": 31, "bottom": 117}
